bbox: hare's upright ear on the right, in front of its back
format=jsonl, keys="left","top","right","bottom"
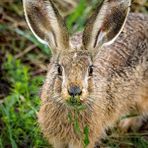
{"left": 82, "top": 0, "right": 131, "bottom": 50}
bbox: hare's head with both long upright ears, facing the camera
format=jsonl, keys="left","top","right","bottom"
{"left": 23, "top": 0, "right": 130, "bottom": 106}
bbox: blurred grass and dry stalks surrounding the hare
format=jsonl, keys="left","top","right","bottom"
{"left": 0, "top": 0, "right": 148, "bottom": 148}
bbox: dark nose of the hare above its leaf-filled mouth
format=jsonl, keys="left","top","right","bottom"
{"left": 68, "top": 86, "right": 82, "bottom": 97}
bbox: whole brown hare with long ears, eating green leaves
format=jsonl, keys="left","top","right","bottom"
{"left": 23, "top": 0, "right": 148, "bottom": 148}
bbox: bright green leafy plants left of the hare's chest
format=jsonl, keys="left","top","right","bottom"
{"left": 0, "top": 55, "right": 47, "bottom": 148}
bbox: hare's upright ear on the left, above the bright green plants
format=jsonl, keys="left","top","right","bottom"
{"left": 23, "top": 0, "right": 69, "bottom": 52}
